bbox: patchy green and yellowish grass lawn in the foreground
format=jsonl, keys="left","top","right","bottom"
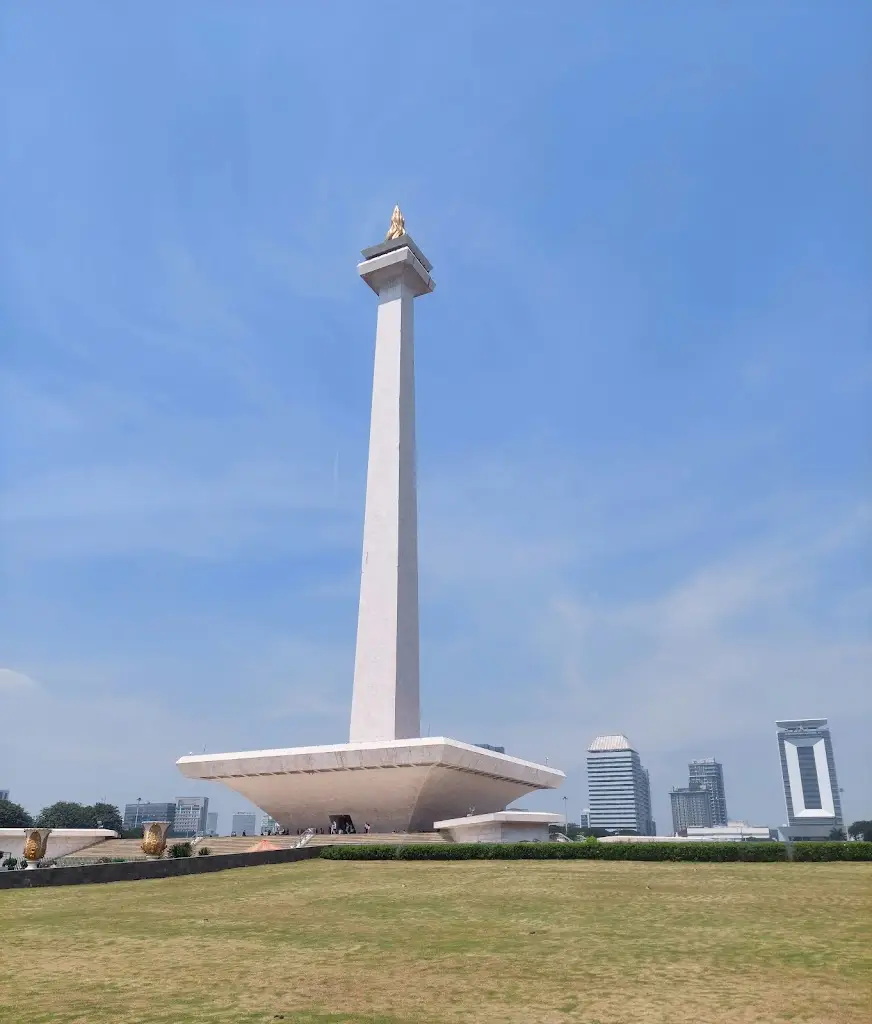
{"left": 0, "top": 860, "right": 872, "bottom": 1024}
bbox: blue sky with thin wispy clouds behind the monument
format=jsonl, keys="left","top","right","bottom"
{"left": 0, "top": 0, "right": 872, "bottom": 830}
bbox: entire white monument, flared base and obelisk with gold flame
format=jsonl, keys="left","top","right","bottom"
{"left": 177, "top": 207, "right": 564, "bottom": 833}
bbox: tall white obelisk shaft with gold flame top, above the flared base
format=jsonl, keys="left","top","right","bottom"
{"left": 349, "top": 207, "right": 434, "bottom": 743}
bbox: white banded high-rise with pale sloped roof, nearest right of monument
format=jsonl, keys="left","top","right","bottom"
{"left": 587, "top": 735, "right": 655, "bottom": 836}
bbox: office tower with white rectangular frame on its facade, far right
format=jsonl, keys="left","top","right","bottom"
{"left": 775, "top": 718, "right": 844, "bottom": 839}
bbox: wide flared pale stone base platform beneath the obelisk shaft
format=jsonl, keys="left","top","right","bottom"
{"left": 176, "top": 736, "right": 565, "bottom": 833}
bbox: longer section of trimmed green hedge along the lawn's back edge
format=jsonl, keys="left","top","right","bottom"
{"left": 321, "top": 843, "right": 786, "bottom": 862}
